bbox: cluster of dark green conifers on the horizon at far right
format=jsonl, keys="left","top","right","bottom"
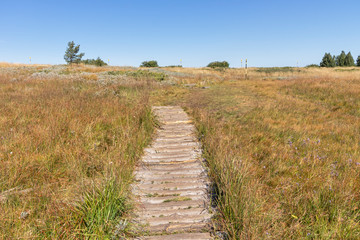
{"left": 320, "top": 51, "right": 360, "bottom": 67}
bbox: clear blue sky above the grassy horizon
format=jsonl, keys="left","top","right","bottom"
{"left": 0, "top": 0, "right": 360, "bottom": 67}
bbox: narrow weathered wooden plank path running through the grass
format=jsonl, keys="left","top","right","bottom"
{"left": 133, "top": 106, "right": 213, "bottom": 240}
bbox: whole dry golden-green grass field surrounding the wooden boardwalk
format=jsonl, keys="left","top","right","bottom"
{"left": 0, "top": 64, "right": 360, "bottom": 239}
